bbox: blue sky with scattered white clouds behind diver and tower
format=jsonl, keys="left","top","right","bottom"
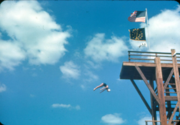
{"left": 0, "top": 1, "right": 180, "bottom": 125}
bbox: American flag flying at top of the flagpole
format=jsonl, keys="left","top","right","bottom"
{"left": 128, "top": 11, "right": 145, "bottom": 23}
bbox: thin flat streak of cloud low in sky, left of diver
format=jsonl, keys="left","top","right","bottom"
{"left": 52, "top": 103, "right": 81, "bottom": 110}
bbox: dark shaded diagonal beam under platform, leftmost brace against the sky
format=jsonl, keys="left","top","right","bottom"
{"left": 130, "top": 79, "right": 152, "bottom": 115}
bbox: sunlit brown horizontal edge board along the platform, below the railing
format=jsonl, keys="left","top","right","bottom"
{"left": 123, "top": 62, "right": 180, "bottom": 68}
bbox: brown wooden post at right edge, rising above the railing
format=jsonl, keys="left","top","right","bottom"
{"left": 171, "top": 49, "right": 180, "bottom": 112}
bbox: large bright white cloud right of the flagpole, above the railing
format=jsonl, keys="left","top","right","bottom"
{"left": 132, "top": 6, "right": 180, "bottom": 52}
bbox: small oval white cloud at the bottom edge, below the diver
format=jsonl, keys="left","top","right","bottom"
{"left": 101, "top": 113, "right": 125, "bottom": 125}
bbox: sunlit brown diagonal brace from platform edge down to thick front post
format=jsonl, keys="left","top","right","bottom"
{"left": 135, "top": 66, "right": 159, "bottom": 104}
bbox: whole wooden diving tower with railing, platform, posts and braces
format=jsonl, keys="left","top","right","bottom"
{"left": 120, "top": 49, "right": 180, "bottom": 125}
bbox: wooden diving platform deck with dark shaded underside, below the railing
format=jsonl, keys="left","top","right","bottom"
{"left": 120, "top": 62, "right": 180, "bottom": 83}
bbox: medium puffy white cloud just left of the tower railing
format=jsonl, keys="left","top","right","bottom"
{"left": 84, "top": 33, "right": 128, "bottom": 62}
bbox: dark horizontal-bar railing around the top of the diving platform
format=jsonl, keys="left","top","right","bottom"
{"left": 128, "top": 51, "right": 180, "bottom": 62}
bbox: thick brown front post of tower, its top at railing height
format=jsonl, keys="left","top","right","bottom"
{"left": 155, "top": 57, "right": 167, "bottom": 125}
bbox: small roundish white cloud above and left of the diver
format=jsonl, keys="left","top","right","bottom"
{"left": 60, "top": 61, "right": 80, "bottom": 79}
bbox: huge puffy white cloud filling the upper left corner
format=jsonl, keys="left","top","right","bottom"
{"left": 0, "top": 1, "right": 70, "bottom": 69}
